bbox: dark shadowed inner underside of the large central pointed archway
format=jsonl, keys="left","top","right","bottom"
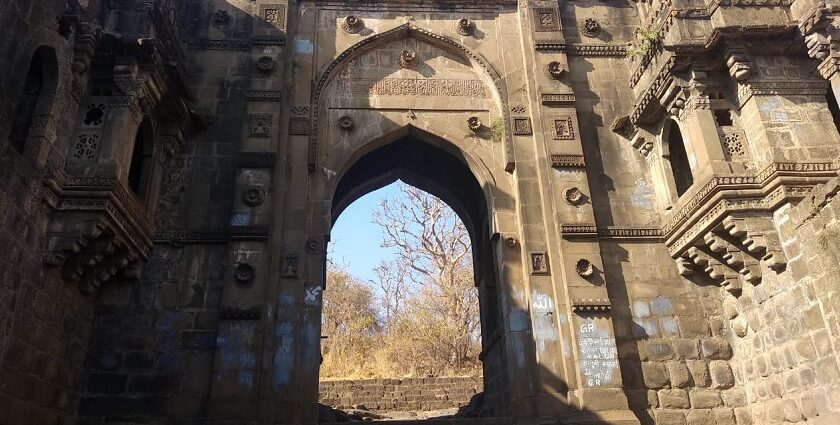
{"left": 322, "top": 132, "right": 504, "bottom": 416}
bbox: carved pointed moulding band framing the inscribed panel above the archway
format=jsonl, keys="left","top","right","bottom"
{"left": 308, "top": 22, "right": 515, "bottom": 172}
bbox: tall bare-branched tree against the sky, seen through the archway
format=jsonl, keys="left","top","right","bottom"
{"left": 374, "top": 184, "right": 480, "bottom": 369}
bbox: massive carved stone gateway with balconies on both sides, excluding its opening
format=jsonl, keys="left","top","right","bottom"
{"left": 0, "top": 0, "right": 840, "bottom": 425}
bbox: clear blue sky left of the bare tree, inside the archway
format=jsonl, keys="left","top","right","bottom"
{"left": 329, "top": 183, "right": 402, "bottom": 282}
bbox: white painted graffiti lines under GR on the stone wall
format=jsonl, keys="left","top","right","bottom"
{"left": 578, "top": 319, "right": 618, "bottom": 387}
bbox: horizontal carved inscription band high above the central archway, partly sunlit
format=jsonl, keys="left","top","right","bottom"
{"left": 335, "top": 78, "right": 487, "bottom": 98}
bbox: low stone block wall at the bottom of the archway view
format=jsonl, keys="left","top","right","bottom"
{"left": 318, "top": 377, "right": 484, "bottom": 411}
